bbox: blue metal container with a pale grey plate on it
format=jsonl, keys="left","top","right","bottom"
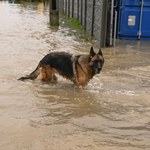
{"left": 118, "top": 0, "right": 150, "bottom": 40}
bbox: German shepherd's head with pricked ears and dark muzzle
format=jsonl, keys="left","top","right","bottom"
{"left": 89, "top": 47, "right": 104, "bottom": 74}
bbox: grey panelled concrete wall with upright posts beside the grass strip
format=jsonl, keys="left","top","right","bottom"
{"left": 59, "top": 0, "right": 107, "bottom": 47}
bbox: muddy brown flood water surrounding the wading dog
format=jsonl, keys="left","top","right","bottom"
{"left": 0, "top": 1, "right": 150, "bottom": 150}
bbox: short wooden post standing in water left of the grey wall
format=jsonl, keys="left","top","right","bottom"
{"left": 49, "top": 0, "right": 59, "bottom": 26}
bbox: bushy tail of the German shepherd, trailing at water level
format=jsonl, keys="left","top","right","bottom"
{"left": 18, "top": 66, "right": 40, "bottom": 81}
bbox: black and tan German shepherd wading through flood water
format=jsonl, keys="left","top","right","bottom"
{"left": 18, "top": 47, "right": 104, "bottom": 87}
